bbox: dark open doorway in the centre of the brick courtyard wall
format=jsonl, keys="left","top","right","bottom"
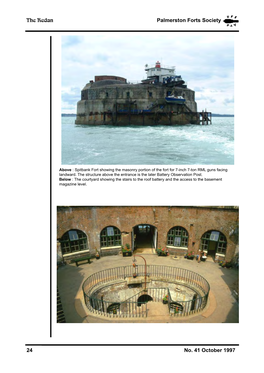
{"left": 131, "top": 224, "right": 158, "bottom": 254}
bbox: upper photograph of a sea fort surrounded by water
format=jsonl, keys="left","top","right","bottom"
{"left": 61, "top": 32, "right": 234, "bottom": 165}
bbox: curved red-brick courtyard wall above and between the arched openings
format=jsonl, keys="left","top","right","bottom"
{"left": 57, "top": 206, "right": 239, "bottom": 261}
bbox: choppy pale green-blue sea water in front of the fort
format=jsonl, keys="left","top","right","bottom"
{"left": 61, "top": 117, "right": 234, "bottom": 165}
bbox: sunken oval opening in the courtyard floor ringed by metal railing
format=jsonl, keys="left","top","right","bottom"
{"left": 83, "top": 265, "right": 210, "bottom": 318}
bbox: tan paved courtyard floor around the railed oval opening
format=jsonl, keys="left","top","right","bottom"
{"left": 57, "top": 252, "right": 238, "bottom": 323}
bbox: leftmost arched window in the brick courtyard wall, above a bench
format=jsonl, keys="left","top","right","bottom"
{"left": 60, "top": 229, "right": 87, "bottom": 255}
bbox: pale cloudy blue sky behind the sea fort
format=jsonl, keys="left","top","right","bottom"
{"left": 61, "top": 32, "right": 234, "bottom": 114}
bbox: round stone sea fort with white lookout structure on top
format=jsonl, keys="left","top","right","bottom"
{"left": 75, "top": 61, "right": 211, "bottom": 125}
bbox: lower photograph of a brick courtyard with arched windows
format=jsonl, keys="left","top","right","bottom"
{"left": 57, "top": 206, "right": 239, "bottom": 323}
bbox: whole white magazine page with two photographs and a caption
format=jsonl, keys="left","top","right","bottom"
{"left": 5, "top": 1, "right": 263, "bottom": 372}
